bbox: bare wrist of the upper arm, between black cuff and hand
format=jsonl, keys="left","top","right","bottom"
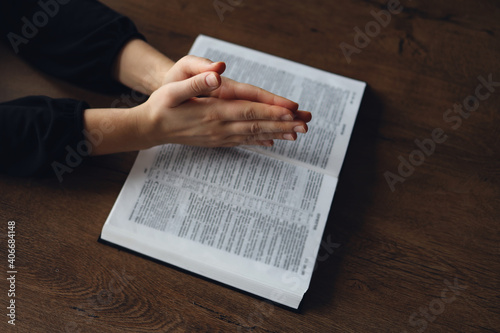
{"left": 113, "top": 39, "right": 174, "bottom": 95}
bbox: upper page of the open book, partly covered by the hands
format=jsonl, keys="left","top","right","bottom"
{"left": 190, "top": 35, "right": 366, "bottom": 177}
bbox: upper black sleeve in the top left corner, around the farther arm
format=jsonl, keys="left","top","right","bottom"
{"left": 0, "top": 0, "right": 144, "bottom": 93}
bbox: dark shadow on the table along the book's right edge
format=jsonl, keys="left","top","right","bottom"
{"left": 300, "top": 87, "right": 383, "bottom": 312}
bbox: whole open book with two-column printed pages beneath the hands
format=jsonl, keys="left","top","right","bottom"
{"left": 101, "top": 35, "right": 365, "bottom": 308}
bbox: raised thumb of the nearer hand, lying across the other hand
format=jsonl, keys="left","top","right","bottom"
{"left": 166, "top": 72, "right": 221, "bottom": 107}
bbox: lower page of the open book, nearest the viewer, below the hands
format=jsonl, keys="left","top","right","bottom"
{"left": 101, "top": 145, "right": 337, "bottom": 307}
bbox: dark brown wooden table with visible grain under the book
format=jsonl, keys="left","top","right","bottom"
{"left": 0, "top": 0, "right": 500, "bottom": 332}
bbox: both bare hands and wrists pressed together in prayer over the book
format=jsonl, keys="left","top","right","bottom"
{"left": 88, "top": 48, "right": 311, "bottom": 155}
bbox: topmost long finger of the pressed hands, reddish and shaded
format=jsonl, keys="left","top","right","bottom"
{"left": 215, "top": 78, "right": 299, "bottom": 112}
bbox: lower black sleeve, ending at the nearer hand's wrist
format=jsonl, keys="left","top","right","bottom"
{"left": 0, "top": 96, "right": 89, "bottom": 180}
